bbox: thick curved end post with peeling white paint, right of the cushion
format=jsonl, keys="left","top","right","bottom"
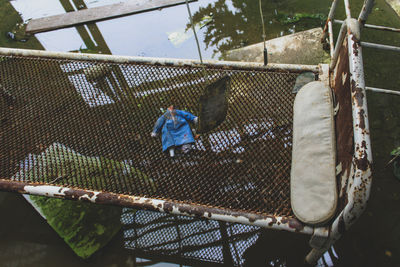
{"left": 306, "top": 19, "right": 372, "bottom": 264}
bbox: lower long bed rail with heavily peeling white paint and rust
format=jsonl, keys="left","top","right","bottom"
{"left": 0, "top": 179, "right": 327, "bottom": 234}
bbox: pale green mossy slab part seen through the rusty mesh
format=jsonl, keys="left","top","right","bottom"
{"left": 13, "top": 143, "right": 155, "bottom": 195}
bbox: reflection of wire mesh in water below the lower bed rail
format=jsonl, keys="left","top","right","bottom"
{"left": 121, "top": 209, "right": 260, "bottom": 266}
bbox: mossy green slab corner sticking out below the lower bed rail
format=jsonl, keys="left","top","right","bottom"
{"left": 30, "top": 196, "right": 122, "bottom": 259}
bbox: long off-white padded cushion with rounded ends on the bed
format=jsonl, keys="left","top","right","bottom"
{"left": 290, "top": 81, "right": 337, "bottom": 225}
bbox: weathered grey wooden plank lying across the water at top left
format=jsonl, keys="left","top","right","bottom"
{"left": 26, "top": 0, "right": 197, "bottom": 34}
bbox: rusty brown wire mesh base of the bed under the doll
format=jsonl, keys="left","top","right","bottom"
{"left": 0, "top": 56, "right": 298, "bottom": 216}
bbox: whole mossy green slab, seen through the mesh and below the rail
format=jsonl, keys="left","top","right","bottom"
{"left": 12, "top": 143, "right": 155, "bottom": 259}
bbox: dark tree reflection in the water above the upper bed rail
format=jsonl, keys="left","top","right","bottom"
{"left": 186, "top": 0, "right": 326, "bottom": 57}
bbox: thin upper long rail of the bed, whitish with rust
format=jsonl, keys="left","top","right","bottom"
{"left": 0, "top": 48, "right": 318, "bottom": 73}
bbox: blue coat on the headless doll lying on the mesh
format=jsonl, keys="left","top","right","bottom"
{"left": 153, "top": 109, "right": 197, "bottom": 151}
